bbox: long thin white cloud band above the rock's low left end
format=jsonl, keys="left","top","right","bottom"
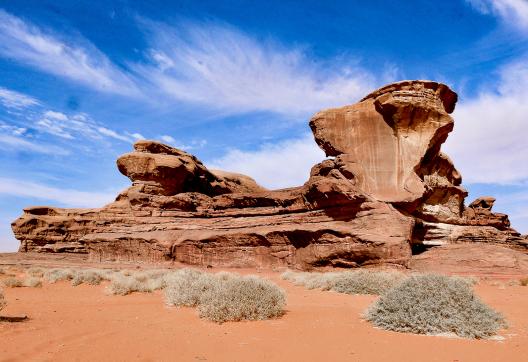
{"left": 0, "top": 178, "right": 117, "bottom": 207}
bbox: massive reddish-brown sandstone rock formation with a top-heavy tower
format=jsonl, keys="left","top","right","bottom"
{"left": 12, "top": 81, "right": 526, "bottom": 269}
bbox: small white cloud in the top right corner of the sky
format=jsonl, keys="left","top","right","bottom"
{"left": 466, "top": 0, "right": 528, "bottom": 31}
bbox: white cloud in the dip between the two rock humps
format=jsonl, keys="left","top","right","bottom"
{"left": 207, "top": 135, "right": 325, "bottom": 189}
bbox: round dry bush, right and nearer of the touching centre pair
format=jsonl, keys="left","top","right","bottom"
{"left": 198, "top": 276, "right": 286, "bottom": 323}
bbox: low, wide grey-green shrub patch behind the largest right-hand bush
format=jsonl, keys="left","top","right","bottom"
{"left": 281, "top": 269, "right": 405, "bottom": 294}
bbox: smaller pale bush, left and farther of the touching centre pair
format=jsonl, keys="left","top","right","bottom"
{"left": 165, "top": 269, "right": 216, "bottom": 307}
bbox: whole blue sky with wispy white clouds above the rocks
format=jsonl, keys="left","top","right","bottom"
{"left": 0, "top": 0, "right": 528, "bottom": 251}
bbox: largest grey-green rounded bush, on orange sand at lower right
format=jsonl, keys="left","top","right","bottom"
{"left": 365, "top": 274, "right": 506, "bottom": 338}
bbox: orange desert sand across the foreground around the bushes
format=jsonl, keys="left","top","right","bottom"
{"left": 0, "top": 264, "right": 528, "bottom": 361}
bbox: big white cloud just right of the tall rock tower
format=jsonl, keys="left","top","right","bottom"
{"left": 444, "top": 58, "right": 528, "bottom": 184}
